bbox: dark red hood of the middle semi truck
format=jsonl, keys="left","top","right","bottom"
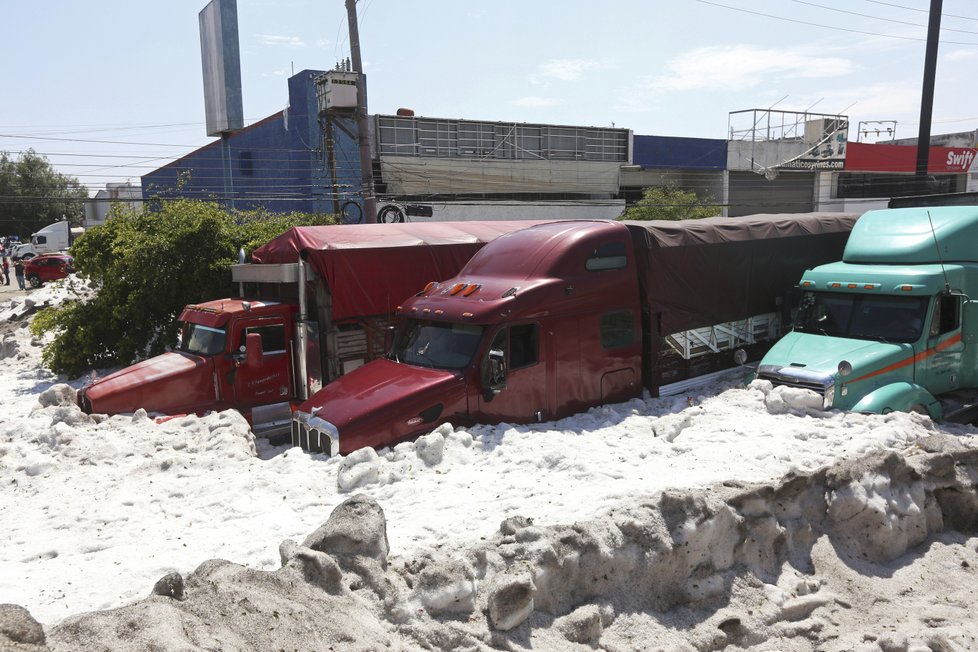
{"left": 298, "top": 359, "right": 468, "bottom": 454}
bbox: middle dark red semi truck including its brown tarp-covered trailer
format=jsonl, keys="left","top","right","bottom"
{"left": 292, "top": 213, "right": 857, "bottom": 454}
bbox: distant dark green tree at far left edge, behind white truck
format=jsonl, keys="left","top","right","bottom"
{"left": 0, "top": 149, "right": 88, "bottom": 238}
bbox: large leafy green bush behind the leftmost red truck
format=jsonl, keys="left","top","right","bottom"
{"left": 31, "top": 199, "right": 334, "bottom": 376}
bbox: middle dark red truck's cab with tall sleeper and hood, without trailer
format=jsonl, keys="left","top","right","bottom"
{"left": 292, "top": 221, "right": 642, "bottom": 454}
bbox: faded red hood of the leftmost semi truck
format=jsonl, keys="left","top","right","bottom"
{"left": 79, "top": 352, "right": 217, "bottom": 414}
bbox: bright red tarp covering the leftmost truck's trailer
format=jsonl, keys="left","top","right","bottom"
{"left": 251, "top": 220, "right": 540, "bottom": 321}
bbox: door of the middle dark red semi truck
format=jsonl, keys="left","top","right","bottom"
{"left": 476, "top": 323, "right": 553, "bottom": 423}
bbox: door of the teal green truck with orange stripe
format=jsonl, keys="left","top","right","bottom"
{"left": 916, "top": 294, "right": 964, "bottom": 395}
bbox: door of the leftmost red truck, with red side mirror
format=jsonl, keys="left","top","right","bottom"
{"left": 231, "top": 318, "right": 292, "bottom": 407}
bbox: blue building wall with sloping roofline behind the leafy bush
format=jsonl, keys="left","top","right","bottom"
{"left": 142, "top": 70, "right": 332, "bottom": 213}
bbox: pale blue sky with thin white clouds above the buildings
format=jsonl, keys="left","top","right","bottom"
{"left": 0, "top": 0, "right": 978, "bottom": 191}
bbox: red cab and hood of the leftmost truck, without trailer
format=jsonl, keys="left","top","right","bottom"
{"left": 79, "top": 298, "right": 298, "bottom": 432}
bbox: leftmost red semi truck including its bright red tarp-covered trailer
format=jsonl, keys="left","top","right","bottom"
{"left": 78, "top": 221, "right": 533, "bottom": 439}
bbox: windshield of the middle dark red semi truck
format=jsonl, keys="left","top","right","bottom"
{"left": 390, "top": 319, "right": 483, "bottom": 369}
